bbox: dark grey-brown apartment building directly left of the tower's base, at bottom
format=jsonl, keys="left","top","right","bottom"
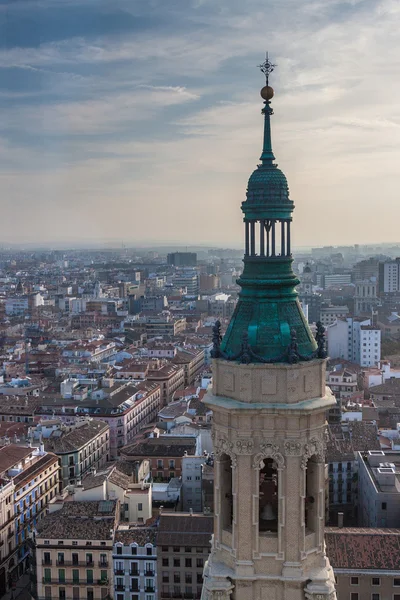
{"left": 157, "top": 513, "right": 214, "bottom": 600}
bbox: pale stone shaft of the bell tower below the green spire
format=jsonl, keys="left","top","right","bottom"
{"left": 202, "top": 360, "right": 336, "bottom": 600}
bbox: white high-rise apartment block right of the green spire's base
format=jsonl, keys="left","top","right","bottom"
{"left": 327, "top": 317, "right": 381, "bottom": 367}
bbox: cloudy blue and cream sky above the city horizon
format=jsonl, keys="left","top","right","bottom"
{"left": 0, "top": 0, "right": 400, "bottom": 247}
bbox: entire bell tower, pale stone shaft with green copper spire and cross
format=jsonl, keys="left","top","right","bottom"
{"left": 202, "top": 56, "right": 336, "bottom": 600}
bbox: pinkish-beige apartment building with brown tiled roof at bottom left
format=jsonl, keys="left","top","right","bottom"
{"left": 36, "top": 500, "right": 119, "bottom": 600}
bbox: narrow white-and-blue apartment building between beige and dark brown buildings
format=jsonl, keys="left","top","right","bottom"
{"left": 113, "top": 525, "right": 158, "bottom": 600}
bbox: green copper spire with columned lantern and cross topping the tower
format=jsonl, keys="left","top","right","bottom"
{"left": 214, "top": 65, "right": 324, "bottom": 363}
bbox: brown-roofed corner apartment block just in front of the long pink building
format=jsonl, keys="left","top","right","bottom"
{"left": 44, "top": 419, "right": 110, "bottom": 487}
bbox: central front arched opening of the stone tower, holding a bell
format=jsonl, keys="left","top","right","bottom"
{"left": 258, "top": 458, "right": 278, "bottom": 532}
